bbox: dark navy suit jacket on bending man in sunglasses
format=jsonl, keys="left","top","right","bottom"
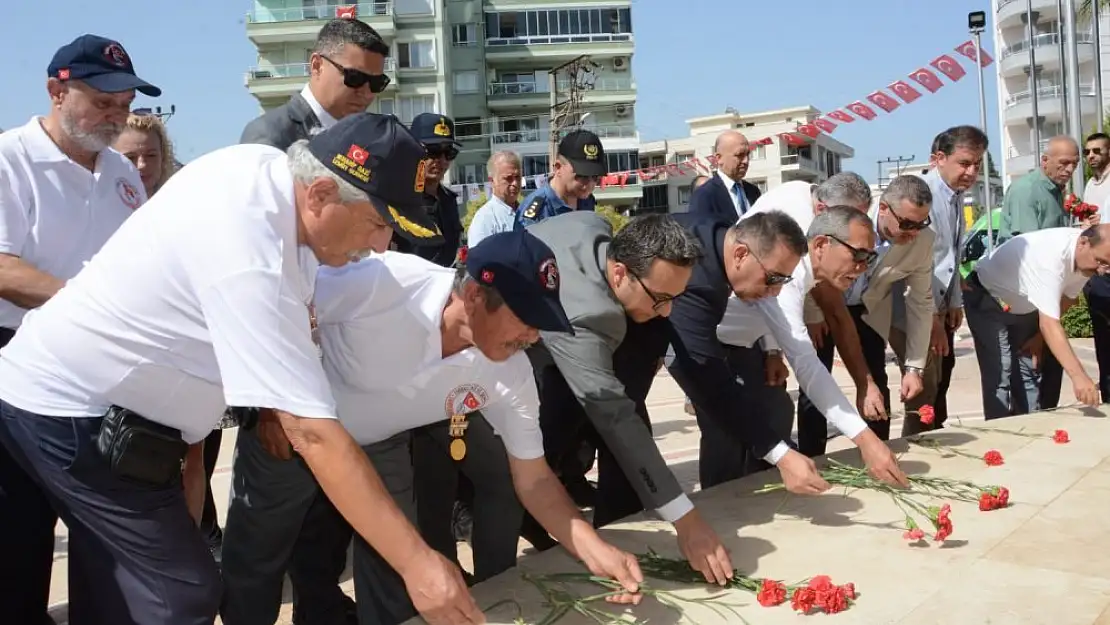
{"left": 666, "top": 212, "right": 783, "bottom": 456}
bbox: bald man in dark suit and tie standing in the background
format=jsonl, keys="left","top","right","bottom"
{"left": 689, "top": 130, "right": 759, "bottom": 221}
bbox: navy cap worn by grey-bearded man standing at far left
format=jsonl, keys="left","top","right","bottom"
{"left": 47, "top": 34, "right": 162, "bottom": 98}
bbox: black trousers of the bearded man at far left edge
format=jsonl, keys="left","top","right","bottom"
{"left": 0, "top": 327, "right": 58, "bottom": 625}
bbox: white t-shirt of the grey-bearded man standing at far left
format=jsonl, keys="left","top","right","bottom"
{"left": 0, "top": 118, "right": 147, "bottom": 329}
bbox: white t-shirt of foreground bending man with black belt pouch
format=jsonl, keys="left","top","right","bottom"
{"left": 0, "top": 145, "right": 335, "bottom": 443}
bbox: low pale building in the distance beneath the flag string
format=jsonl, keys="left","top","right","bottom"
{"left": 638, "top": 107, "right": 855, "bottom": 213}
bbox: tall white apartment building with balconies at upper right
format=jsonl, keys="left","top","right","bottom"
{"left": 993, "top": 0, "right": 1110, "bottom": 187}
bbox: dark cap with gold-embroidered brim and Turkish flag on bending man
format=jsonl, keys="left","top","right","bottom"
{"left": 309, "top": 113, "right": 443, "bottom": 245}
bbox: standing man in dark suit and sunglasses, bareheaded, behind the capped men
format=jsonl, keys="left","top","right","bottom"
{"left": 231, "top": 14, "right": 390, "bottom": 625}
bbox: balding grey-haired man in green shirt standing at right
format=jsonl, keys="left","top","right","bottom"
{"left": 998, "top": 134, "right": 1079, "bottom": 243}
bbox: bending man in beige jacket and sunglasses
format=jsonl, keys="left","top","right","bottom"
{"left": 845, "top": 175, "right": 945, "bottom": 441}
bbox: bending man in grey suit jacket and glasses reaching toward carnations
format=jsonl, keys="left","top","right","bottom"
{"left": 528, "top": 211, "right": 733, "bottom": 584}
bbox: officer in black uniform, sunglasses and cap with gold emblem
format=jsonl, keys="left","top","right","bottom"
{"left": 396, "top": 113, "right": 463, "bottom": 266}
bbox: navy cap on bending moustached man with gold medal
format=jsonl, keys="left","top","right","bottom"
{"left": 466, "top": 230, "right": 574, "bottom": 334}
